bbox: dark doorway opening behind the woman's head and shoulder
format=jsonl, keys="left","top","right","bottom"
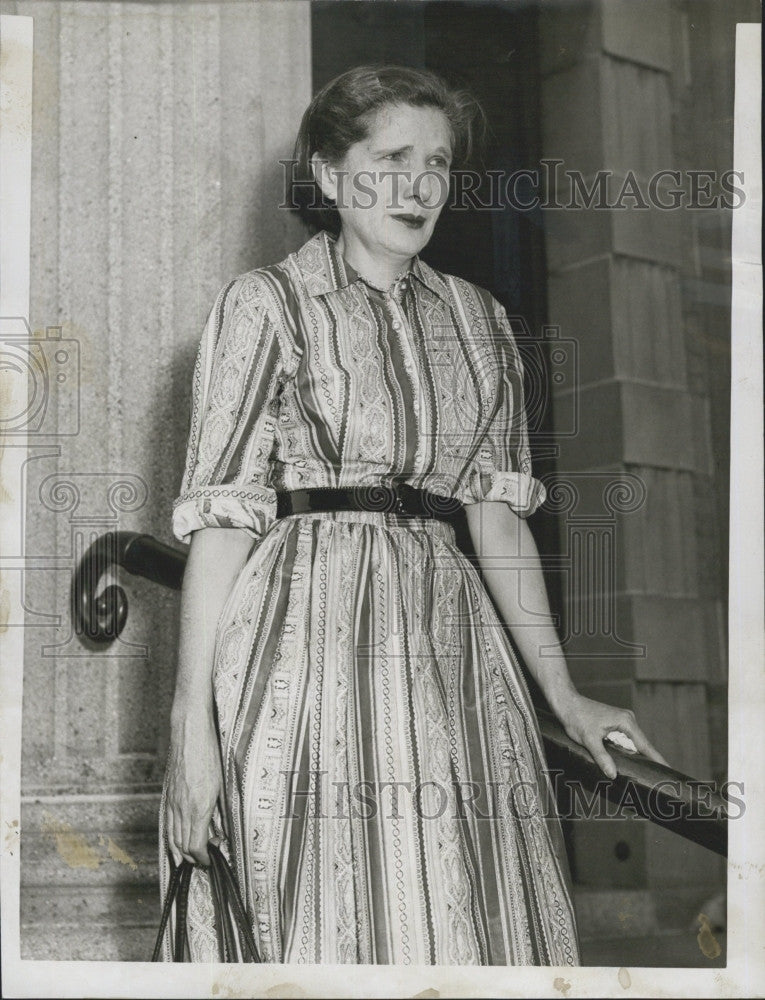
{"left": 311, "top": 0, "right": 560, "bottom": 728}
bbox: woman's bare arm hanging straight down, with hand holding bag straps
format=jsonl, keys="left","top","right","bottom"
{"left": 165, "top": 528, "right": 253, "bottom": 865}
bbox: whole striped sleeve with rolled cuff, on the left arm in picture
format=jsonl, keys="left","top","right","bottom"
{"left": 172, "top": 273, "right": 283, "bottom": 543}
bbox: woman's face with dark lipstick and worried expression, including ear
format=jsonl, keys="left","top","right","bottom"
{"left": 314, "top": 104, "right": 452, "bottom": 260}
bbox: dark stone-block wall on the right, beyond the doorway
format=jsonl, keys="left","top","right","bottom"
{"left": 540, "top": 0, "right": 732, "bottom": 936}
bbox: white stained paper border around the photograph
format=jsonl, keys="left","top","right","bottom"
{"left": 0, "top": 9, "right": 765, "bottom": 998}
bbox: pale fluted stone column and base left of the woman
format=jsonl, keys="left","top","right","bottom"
{"left": 3, "top": 0, "right": 311, "bottom": 960}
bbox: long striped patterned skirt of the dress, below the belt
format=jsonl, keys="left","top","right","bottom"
{"left": 160, "top": 511, "right": 579, "bottom": 966}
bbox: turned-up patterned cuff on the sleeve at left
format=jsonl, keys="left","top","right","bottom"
{"left": 173, "top": 486, "right": 276, "bottom": 545}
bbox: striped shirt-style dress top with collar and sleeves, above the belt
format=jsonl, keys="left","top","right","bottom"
{"left": 173, "top": 232, "right": 545, "bottom": 541}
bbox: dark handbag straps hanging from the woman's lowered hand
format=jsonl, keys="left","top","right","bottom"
{"left": 151, "top": 840, "right": 261, "bottom": 962}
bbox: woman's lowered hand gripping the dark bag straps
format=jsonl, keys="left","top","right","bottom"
{"left": 165, "top": 717, "right": 222, "bottom": 866}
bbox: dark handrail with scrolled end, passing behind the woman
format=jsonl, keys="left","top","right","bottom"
{"left": 71, "top": 531, "right": 728, "bottom": 857}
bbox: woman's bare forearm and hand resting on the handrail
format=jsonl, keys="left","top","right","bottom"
{"left": 465, "top": 501, "right": 667, "bottom": 778}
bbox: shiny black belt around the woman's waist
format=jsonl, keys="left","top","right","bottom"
{"left": 276, "top": 483, "right": 462, "bottom": 521}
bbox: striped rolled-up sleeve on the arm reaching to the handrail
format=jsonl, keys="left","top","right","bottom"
{"left": 461, "top": 301, "right": 547, "bottom": 517}
